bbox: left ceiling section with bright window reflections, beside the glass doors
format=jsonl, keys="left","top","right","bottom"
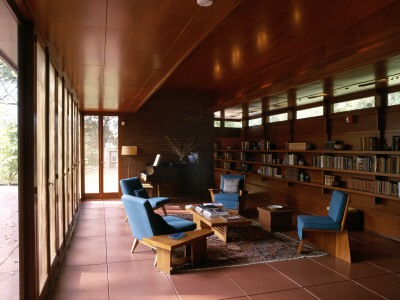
{"left": 26, "top": 0, "right": 241, "bottom": 112}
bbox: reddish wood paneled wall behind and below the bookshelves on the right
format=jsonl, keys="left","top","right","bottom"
{"left": 219, "top": 106, "right": 400, "bottom": 238}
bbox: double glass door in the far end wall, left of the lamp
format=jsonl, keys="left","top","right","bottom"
{"left": 84, "top": 115, "right": 119, "bottom": 199}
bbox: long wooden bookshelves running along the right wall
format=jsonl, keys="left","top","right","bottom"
{"left": 214, "top": 149, "right": 400, "bottom": 204}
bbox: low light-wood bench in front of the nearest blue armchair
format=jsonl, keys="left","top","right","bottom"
{"left": 143, "top": 229, "right": 213, "bottom": 274}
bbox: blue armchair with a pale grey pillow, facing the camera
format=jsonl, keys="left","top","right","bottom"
{"left": 209, "top": 175, "right": 246, "bottom": 213}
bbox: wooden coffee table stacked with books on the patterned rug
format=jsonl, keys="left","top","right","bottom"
{"left": 186, "top": 207, "right": 251, "bottom": 243}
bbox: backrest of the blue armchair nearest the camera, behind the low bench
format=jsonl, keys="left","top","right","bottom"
{"left": 121, "top": 195, "right": 169, "bottom": 240}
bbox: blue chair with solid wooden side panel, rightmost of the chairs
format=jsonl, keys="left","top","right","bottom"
{"left": 297, "top": 190, "right": 351, "bottom": 262}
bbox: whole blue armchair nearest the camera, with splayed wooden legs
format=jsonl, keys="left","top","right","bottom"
{"left": 121, "top": 195, "right": 197, "bottom": 253}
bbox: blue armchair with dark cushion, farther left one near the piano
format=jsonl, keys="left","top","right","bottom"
{"left": 119, "top": 177, "right": 170, "bottom": 216}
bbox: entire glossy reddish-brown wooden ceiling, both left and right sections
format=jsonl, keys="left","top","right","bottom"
{"left": 22, "top": 0, "right": 400, "bottom": 112}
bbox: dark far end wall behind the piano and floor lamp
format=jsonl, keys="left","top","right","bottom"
{"left": 121, "top": 92, "right": 214, "bottom": 198}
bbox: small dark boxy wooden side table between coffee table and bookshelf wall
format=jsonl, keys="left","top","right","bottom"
{"left": 257, "top": 206, "right": 293, "bottom": 231}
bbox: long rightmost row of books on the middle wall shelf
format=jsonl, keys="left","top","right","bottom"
{"left": 312, "top": 155, "right": 400, "bottom": 174}
